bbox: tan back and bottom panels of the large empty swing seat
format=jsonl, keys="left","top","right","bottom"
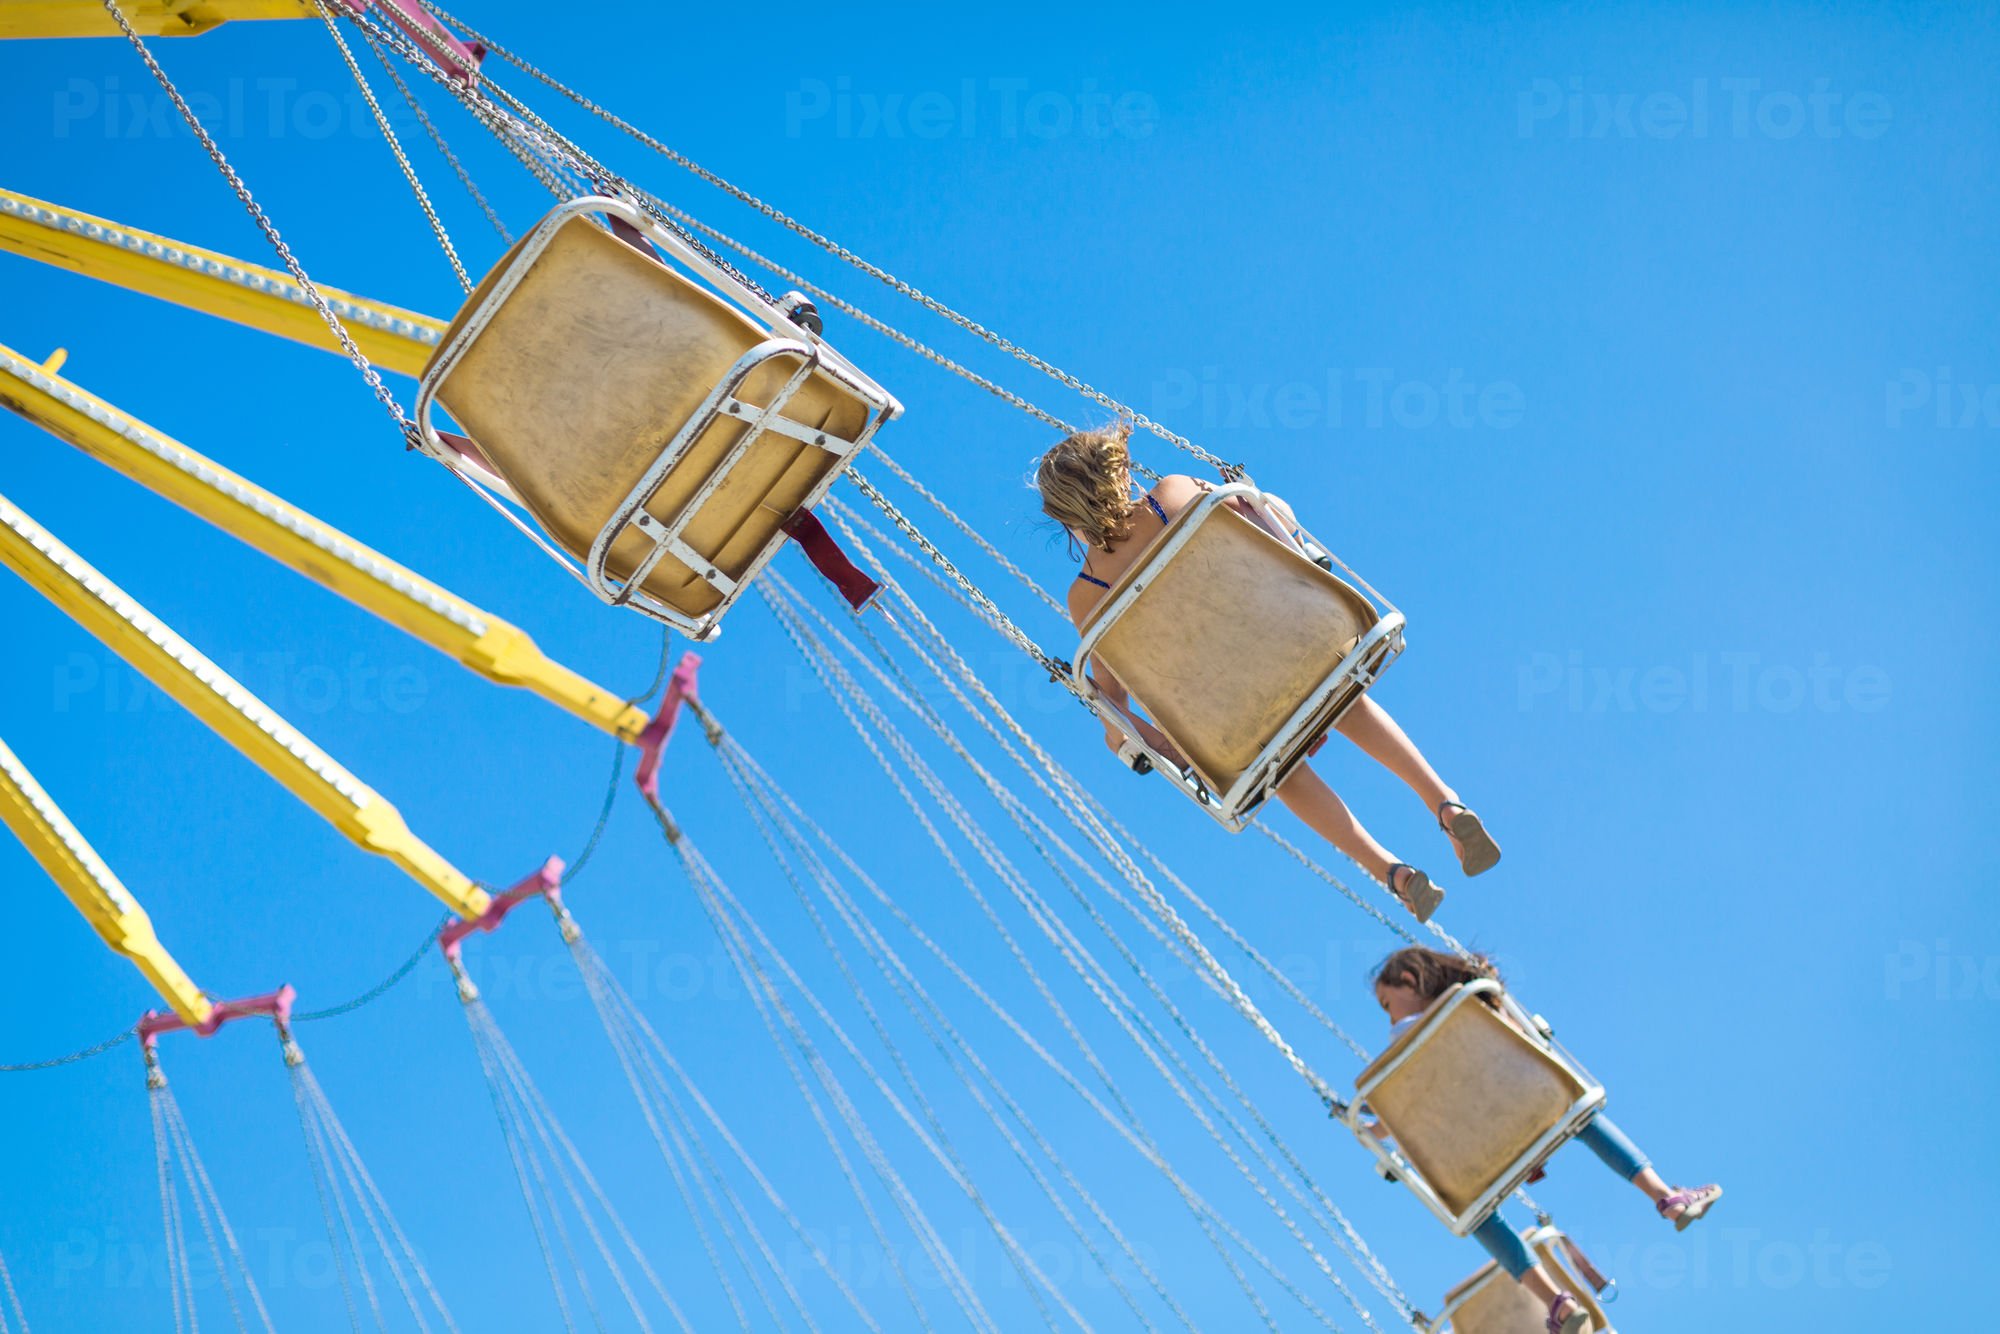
{"left": 426, "top": 216, "right": 870, "bottom": 616}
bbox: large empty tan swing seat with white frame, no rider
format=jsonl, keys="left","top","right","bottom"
{"left": 416, "top": 196, "right": 902, "bottom": 638}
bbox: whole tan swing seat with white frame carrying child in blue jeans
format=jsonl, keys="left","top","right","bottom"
{"left": 1348, "top": 980, "right": 1604, "bottom": 1236}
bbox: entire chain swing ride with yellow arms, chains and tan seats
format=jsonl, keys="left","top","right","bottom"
{"left": 0, "top": 0, "right": 1704, "bottom": 1334}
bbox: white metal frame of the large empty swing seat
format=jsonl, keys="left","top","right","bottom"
{"left": 416, "top": 194, "right": 902, "bottom": 640}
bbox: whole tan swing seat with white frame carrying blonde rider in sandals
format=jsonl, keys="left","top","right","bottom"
{"left": 1074, "top": 482, "right": 1404, "bottom": 830}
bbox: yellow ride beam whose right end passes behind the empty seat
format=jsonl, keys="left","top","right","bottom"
{"left": 0, "top": 188, "right": 444, "bottom": 376}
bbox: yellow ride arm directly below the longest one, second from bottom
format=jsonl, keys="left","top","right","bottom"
{"left": 0, "top": 496, "right": 492, "bottom": 918}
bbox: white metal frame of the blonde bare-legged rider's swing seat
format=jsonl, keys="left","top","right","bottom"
{"left": 1070, "top": 482, "right": 1404, "bottom": 834}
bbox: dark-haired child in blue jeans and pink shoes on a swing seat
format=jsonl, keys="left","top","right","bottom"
{"left": 1374, "top": 946, "right": 1722, "bottom": 1334}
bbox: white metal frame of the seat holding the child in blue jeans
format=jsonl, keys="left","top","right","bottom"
{"left": 1344, "top": 978, "right": 1606, "bottom": 1236}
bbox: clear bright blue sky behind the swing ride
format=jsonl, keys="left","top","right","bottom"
{"left": 0, "top": 0, "right": 2000, "bottom": 1332}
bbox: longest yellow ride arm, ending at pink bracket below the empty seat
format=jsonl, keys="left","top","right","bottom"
{"left": 0, "top": 342, "right": 646, "bottom": 742}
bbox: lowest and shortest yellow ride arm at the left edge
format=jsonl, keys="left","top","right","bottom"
{"left": 0, "top": 742, "right": 212, "bottom": 1028}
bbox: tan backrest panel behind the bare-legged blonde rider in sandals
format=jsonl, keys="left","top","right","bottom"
{"left": 1084, "top": 504, "right": 1378, "bottom": 792}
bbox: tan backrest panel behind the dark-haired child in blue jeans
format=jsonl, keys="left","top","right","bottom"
{"left": 1358, "top": 986, "right": 1586, "bottom": 1214}
